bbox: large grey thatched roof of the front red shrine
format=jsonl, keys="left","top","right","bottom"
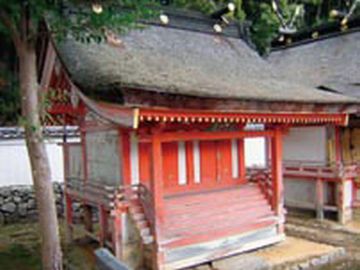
{"left": 57, "top": 22, "right": 354, "bottom": 103}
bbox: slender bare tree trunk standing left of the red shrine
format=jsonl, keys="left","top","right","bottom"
{"left": 18, "top": 41, "right": 62, "bottom": 270}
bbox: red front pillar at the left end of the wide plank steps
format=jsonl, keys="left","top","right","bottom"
{"left": 150, "top": 134, "right": 164, "bottom": 269}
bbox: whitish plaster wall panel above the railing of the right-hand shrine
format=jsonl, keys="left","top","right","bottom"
{"left": 283, "top": 127, "right": 327, "bottom": 163}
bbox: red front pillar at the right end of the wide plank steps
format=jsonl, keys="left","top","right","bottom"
{"left": 271, "top": 128, "right": 284, "bottom": 233}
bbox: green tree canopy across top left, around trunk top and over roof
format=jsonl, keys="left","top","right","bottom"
{"left": 0, "top": 0, "right": 158, "bottom": 42}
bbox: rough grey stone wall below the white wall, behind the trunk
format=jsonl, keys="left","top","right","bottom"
{"left": 0, "top": 183, "right": 64, "bottom": 225}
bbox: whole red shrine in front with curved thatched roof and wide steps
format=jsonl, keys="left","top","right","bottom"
{"left": 39, "top": 11, "right": 357, "bottom": 269}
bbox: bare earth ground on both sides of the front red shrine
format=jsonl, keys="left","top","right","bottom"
{"left": 0, "top": 216, "right": 360, "bottom": 270}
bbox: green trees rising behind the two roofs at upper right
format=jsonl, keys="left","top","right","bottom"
{"left": 174, "top": 0, "right": 360, "bottom": 53}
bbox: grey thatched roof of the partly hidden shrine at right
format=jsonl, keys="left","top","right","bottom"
{"left": 268, "top": 32, "right": 360, "bottom": 97}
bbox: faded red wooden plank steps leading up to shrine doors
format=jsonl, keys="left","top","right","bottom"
{"left": 160, "top": 184, "right": 277, "bottom": 249}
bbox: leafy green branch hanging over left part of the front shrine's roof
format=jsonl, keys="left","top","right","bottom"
{"left": 46, "top": 0, "right": 157, "bottom": 42}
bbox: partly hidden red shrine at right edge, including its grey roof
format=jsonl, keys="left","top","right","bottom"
{"left": 268, "top": 25, "right": 360, "bottom": 223}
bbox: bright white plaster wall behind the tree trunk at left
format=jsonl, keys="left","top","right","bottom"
{"left": 0, "top": 139, "right": 72, "bottom": 186}
